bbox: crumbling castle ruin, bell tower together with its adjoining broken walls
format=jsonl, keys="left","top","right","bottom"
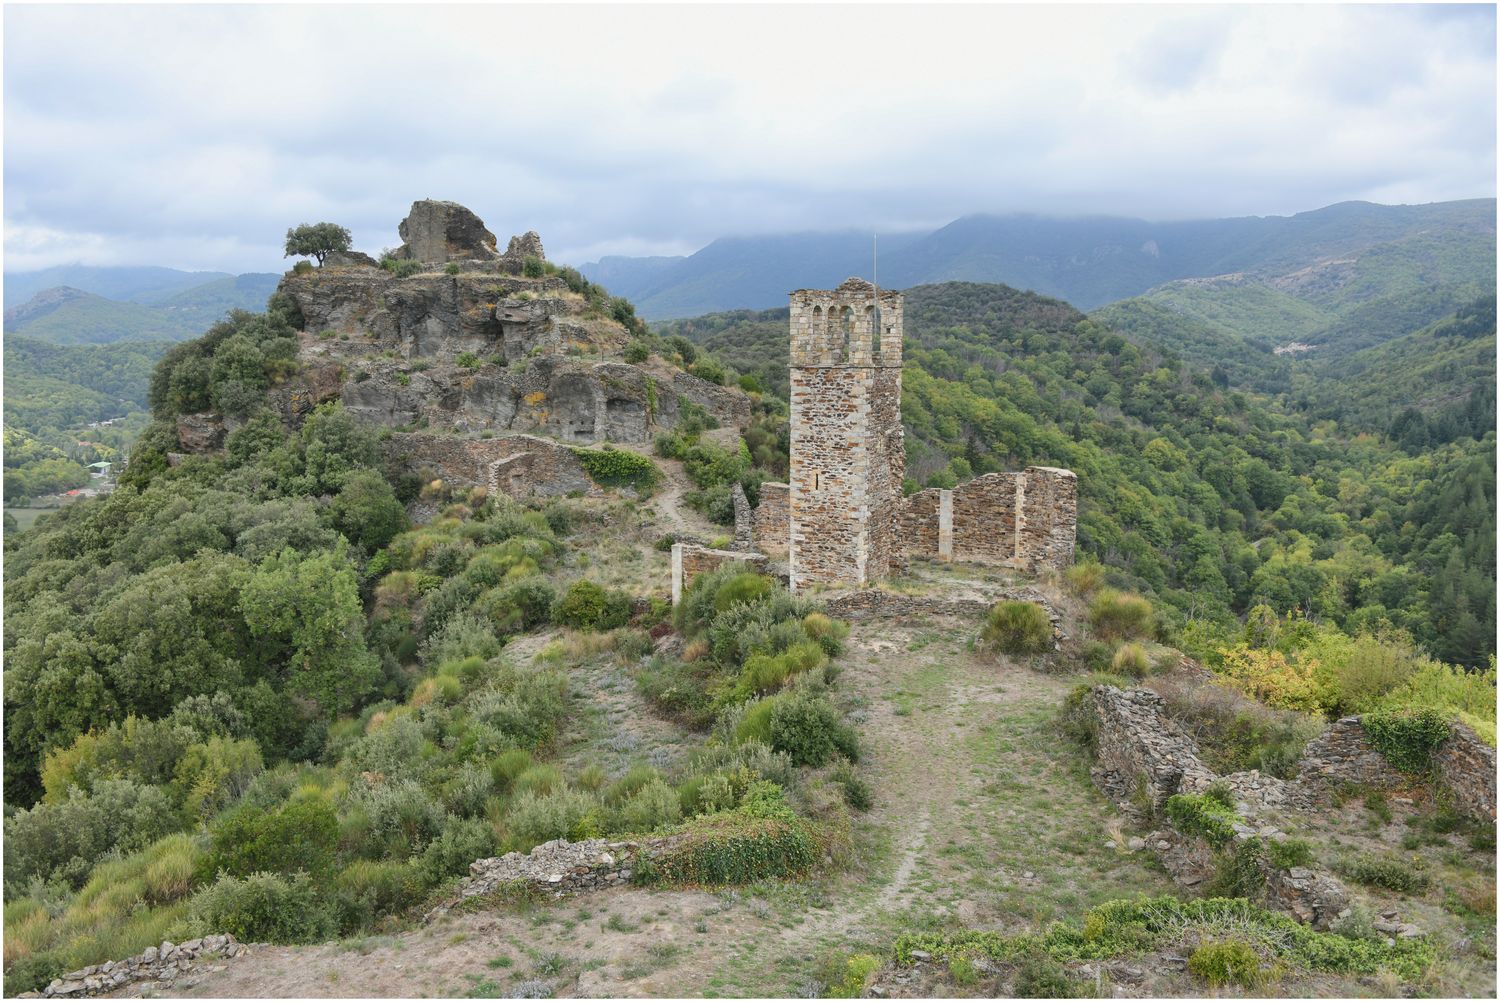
{"left": 674, "top": 278, "right": 1079, "bottom": 597}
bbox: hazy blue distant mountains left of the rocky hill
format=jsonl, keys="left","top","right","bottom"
{"left": 5, "top": 269, "right": 281, "bottom": 345}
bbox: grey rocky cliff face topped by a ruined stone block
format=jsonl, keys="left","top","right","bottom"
{"left": 250, "top": 203, "right": 750, "bottom": 444}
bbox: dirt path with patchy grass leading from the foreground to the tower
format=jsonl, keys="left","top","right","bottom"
{"left": 138, "top": 615, "right": 1166, "bottom": 998}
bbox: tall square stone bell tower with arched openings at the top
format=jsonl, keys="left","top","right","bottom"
{"left": 789, "top": 279, "right": 906, "bottom": 591}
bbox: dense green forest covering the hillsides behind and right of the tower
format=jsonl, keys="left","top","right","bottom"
{"left": 660, "top": 284, "right": 1496, "bottom": 665}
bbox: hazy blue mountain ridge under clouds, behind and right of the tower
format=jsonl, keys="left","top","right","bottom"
{"left": 582, "top": 198, "right": 1496, "bottom": 320}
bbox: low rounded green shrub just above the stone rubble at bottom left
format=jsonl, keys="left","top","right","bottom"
{"left": 189, "top": 873, "right": 336, "bottom": 944}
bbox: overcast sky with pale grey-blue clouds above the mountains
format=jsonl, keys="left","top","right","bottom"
{"left": 5, "top": 5, "right": 1496, "bottom": 272}
